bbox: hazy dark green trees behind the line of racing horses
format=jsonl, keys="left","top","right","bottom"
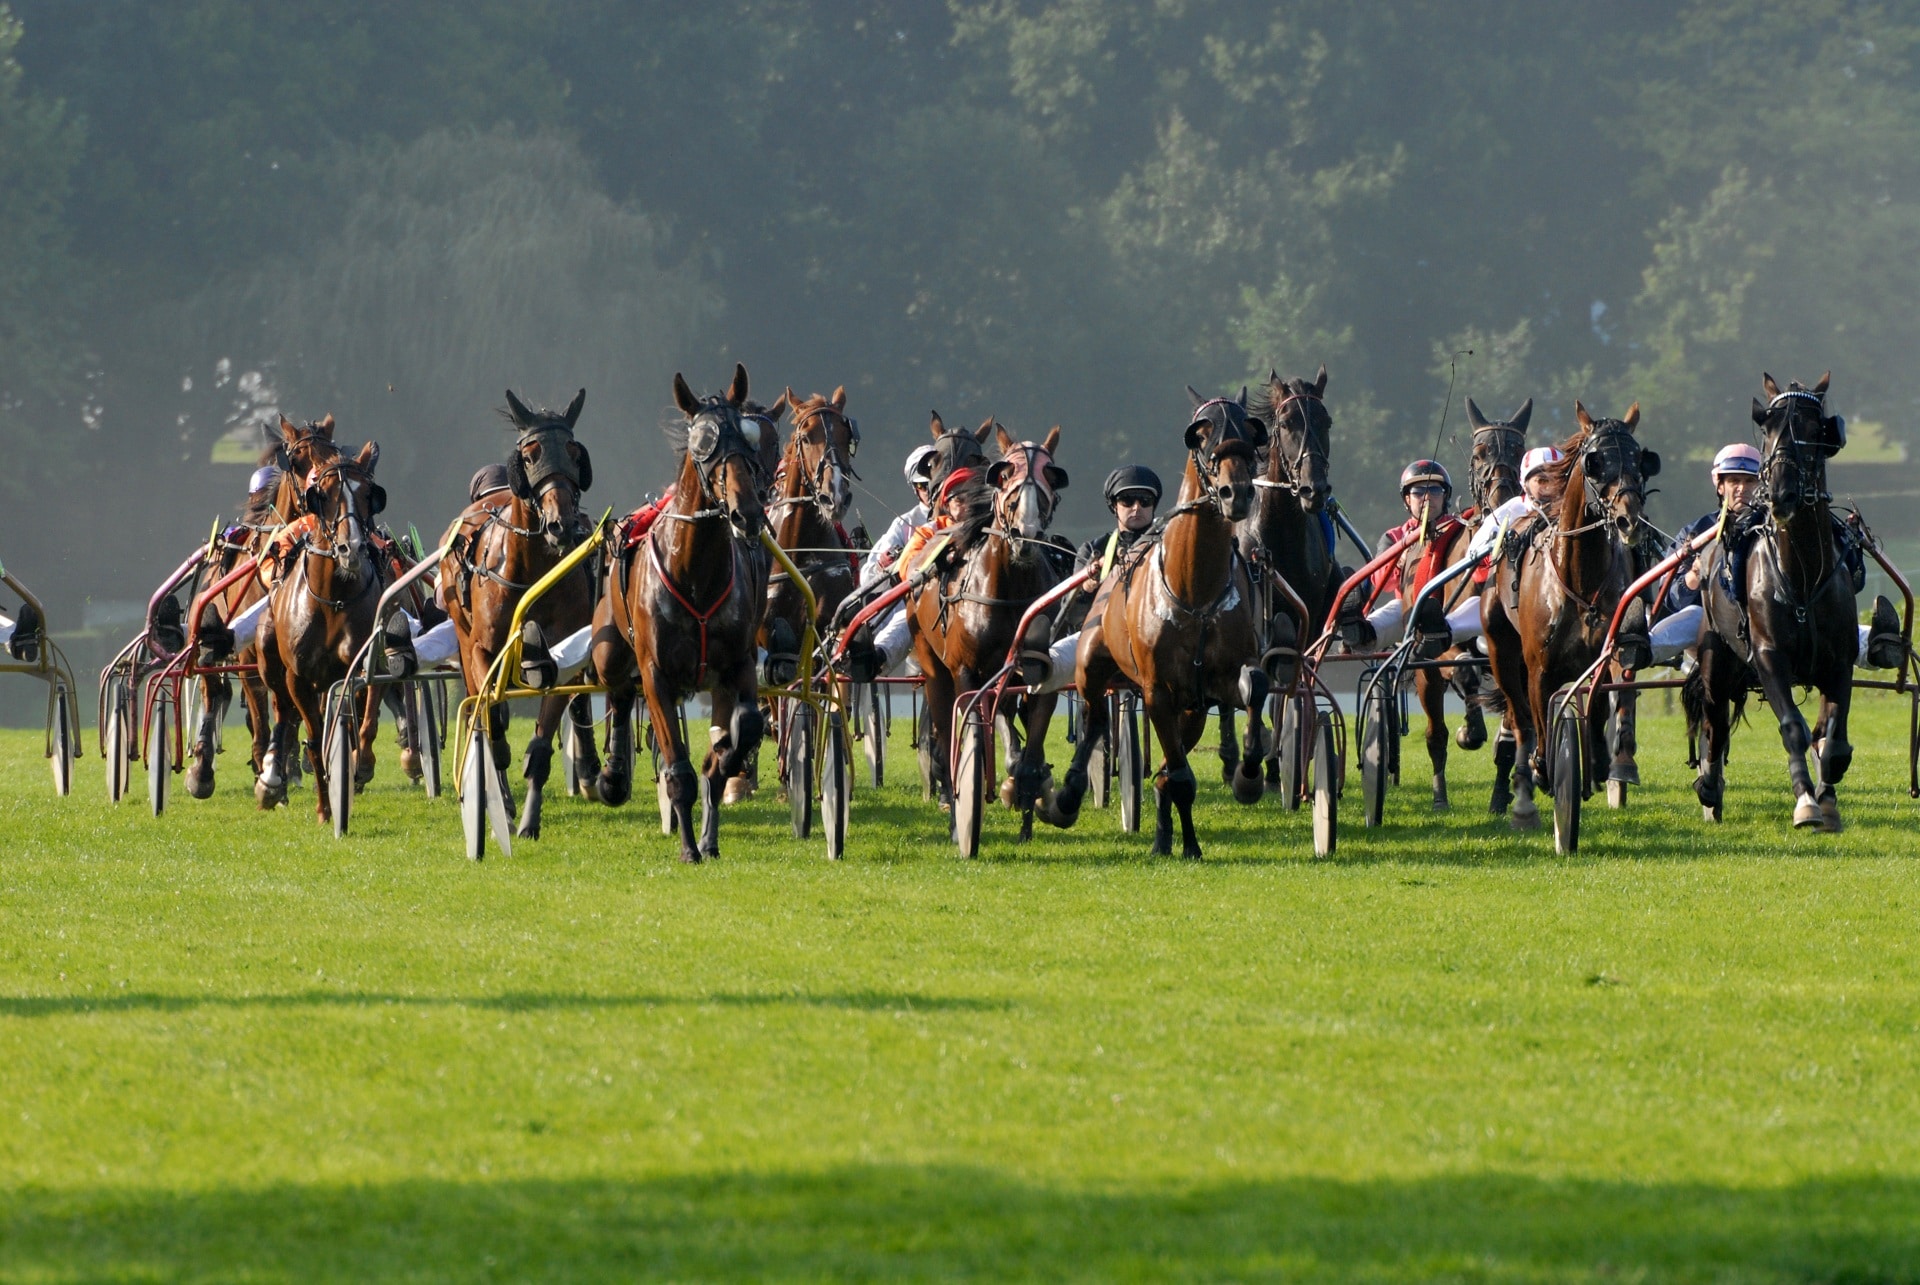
{"left": 0, "top": 0, "right": 1920, "bottom": 720}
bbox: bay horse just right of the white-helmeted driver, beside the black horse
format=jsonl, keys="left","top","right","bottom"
{"left": 1480, "top": 401, "right": 1659, "bottom": 830}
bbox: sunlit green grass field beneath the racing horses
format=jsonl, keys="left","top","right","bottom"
{"left": 0, "top": 699, "right": 1920, "bottom": 1281}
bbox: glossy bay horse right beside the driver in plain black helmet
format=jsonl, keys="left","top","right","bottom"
{"left": 1046, "top": 388, "right": 1267, "bottom": 859}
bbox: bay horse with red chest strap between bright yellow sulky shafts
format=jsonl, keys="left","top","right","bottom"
{"left": 593, "top": 365, "right": 768, "bottom": 862}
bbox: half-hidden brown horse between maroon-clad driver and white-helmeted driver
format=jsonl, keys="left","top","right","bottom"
{"left": 1400, "top": 398, "right": 1534, "bottom": 811}
